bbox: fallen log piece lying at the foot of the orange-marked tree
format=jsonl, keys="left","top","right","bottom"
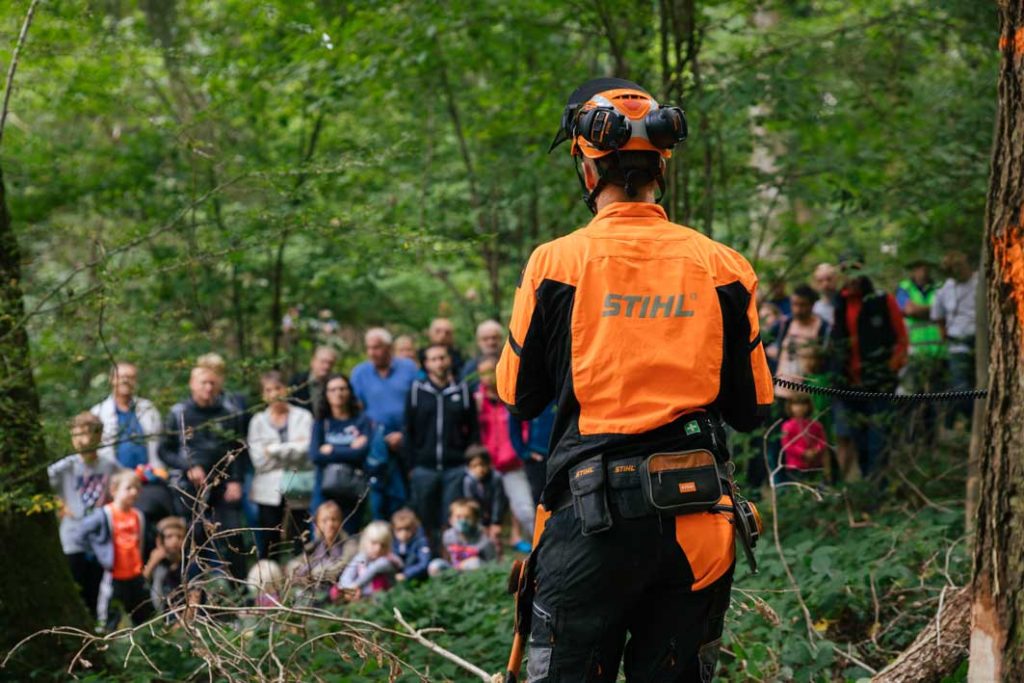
{"left": 871, "top": 587, "right": 971, "bottom": 683}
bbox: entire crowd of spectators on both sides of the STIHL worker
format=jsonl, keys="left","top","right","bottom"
{"left": 49, "top": 252, "right": 977, "bottom": 628}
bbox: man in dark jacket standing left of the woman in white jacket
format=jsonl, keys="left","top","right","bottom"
{"left": 160, "top": 368, "right": 246, "bottom": 579}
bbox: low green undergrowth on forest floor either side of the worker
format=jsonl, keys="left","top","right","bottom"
{"left": 18, "top": 432, "right": 970, "bottom": 682}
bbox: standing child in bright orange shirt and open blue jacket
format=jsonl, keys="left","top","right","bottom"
{"left": 78, "top": 470, "right": 154, "bottom": 629}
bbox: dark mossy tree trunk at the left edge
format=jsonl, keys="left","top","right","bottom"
{"left": 0, "top": 170, "right": 87, "bottom": 675}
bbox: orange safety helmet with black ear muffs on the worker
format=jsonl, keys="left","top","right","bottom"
{"left": 548, "top": 78, "right": 687, "bottom": 159}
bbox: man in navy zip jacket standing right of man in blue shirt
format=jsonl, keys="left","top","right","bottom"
{"left": 402, "top": 344, "right": 479, "bottom": 541}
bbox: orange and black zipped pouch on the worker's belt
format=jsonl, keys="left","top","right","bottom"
{"left": 640, "top": 449, "right": 723, "bottom": 515}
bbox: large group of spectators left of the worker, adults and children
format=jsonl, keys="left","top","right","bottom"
{"left": 49, "top": 318, "right": 553, "bottom": 629}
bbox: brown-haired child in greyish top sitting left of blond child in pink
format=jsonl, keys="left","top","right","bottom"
{"left": 288, "top": 501, "right": 359, "bottom": 596}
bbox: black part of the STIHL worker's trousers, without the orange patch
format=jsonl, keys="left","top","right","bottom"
{"left": 526, "top": 506, "right": 732, "bottom": 683}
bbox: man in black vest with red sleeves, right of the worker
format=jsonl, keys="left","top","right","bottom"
{"left": 833, "top": 252, "right": 908, "bottom": 480}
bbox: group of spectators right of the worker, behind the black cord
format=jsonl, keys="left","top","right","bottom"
{"left": 748, "top": 252, "right": 977, "bottom": 489}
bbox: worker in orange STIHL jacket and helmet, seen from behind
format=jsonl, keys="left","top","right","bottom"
{"left": 498, "top": 78, "right": 772, "bottom": 682}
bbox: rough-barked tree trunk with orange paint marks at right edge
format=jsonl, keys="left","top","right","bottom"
{"left": 969, "top": 0, "right": 1024, "bottom": 681}
